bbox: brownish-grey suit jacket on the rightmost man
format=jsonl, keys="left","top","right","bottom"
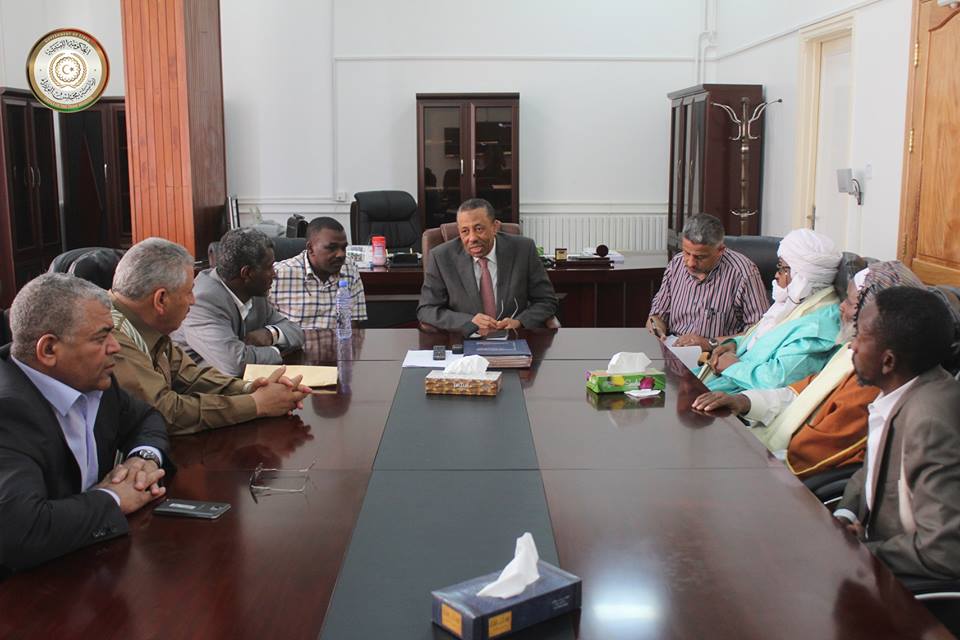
{"left": 839, "top": 367, "right": 960, "bottom": 579}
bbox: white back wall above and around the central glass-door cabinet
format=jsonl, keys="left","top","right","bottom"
{"left": 221, "top": 0, "right": 702, "bottom": 249}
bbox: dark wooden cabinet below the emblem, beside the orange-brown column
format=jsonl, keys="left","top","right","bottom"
{"left": 59, "top": 98, "right": 133, "bottom": 249}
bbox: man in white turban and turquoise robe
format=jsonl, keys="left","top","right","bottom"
{"left": 701, "top": 229, "right": 842, "bottom": 393}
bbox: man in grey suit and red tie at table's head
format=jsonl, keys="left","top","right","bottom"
{"left": 417, "top": 198, "right": 560, "bottom": 335}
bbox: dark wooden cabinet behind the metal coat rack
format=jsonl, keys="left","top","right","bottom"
{"left": 667, "top": 84, "right": 763, "bottom": 255}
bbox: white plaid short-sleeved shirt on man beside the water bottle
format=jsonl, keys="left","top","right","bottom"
{"left": 270, "top": 251, "right": 367, "bottom": 329}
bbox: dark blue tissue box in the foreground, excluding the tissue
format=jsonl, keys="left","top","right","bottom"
{"left": 430, "top": 560, "right": 581, "bottom": 640}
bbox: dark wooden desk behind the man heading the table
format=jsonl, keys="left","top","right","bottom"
{"left": 360, "top": 254, "right": 666, "bottom": 328}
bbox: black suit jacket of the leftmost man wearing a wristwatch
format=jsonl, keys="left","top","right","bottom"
{"left": 0, "top": 346, "right": 173, "bottom": 573}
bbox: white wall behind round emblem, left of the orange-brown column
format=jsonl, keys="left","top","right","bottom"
{"left": 0, "top": 0, "right": 124, "bottom": 96}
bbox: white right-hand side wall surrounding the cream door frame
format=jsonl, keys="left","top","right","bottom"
{"left": 711, "top": 0, "right": 911, "bottom": 259}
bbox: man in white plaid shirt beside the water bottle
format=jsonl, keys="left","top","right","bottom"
{"left": 270, "top": 217, "right": 367, "bottom": 329}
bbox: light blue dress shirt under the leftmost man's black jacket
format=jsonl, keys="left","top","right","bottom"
{"left": 10, "top": 356, "right": 163, "bottom": 506}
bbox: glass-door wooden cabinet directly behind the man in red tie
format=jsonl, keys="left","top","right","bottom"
{"left": 417, "top": 93, "right": 520, "bottom": 229}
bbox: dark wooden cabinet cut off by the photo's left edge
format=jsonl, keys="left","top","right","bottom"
{"left": 0, "top": 89, "right": 61, "bottom": 307}
